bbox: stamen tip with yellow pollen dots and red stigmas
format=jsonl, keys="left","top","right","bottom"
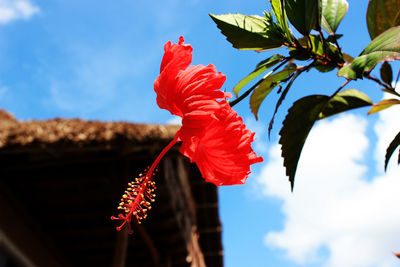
{"left": 111, "top": 170, "right": 157, "bottom": 234}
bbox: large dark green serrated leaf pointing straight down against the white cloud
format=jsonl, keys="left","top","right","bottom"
{"left": 279, "top": 95, "right": 329, "bottom": 191}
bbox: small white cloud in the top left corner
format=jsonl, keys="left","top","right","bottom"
{"left": 0, "top": 0, "right": 40, "bottom": 24}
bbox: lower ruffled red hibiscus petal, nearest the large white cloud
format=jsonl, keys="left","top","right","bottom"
{"left": 180, "top": 101, "right": 263, "bottom": 186}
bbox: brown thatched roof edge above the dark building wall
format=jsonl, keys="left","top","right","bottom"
{"left": 0, "top": 109, "right": 179, "bottom": 148}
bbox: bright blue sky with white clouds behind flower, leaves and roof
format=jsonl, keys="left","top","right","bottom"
{"left": 0, "top": 0, "right": 400, "bottom": 267}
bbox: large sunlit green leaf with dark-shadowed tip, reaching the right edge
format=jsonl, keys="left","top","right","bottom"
{"left": 338, "top": 26, "right": 400, "bottom": 80}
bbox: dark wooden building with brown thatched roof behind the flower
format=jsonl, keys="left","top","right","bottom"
{"left": 0, "top": 110, "right": 223, "bottom": 267}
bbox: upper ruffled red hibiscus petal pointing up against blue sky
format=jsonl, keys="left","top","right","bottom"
{"left": 154, "top": 38, "right": 231, "bottom": 117}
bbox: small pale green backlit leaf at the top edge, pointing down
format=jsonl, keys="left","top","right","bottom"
{"left": 321, "top": 0, "right": 349, "bottom": 35}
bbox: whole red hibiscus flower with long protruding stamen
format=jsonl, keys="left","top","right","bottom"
{"left": 111, "top": 37, "right": 263, "bottom": 231}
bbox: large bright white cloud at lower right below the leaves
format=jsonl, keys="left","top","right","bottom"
{"left": 258, "top": 109, "right": 400, "bottom": 267}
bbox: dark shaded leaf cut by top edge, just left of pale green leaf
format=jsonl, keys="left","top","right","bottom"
{"left": 284, "top": 0, "right": 321, "bottom": 35}
